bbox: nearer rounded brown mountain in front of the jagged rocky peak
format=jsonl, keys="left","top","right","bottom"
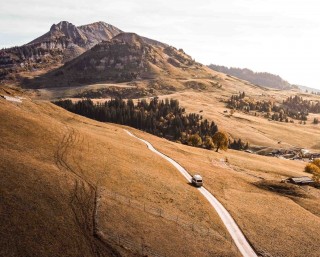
{"left": 21, "top": 33, "right": 212, "bottom": 88}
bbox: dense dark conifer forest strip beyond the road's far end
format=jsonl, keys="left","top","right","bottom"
{"left": 53, "top": 97, "right": 238, "bottom": 151}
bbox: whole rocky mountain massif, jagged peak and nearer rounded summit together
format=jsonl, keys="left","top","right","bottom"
{"left": 0, "top": 21, "right": 213, "bottom": 88}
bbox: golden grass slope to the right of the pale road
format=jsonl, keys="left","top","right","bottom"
{"left": 135, "top": 132, "right": 320, "bottom": 257}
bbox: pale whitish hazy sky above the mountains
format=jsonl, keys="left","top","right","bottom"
{"left": 0, "top": 0, "right": 320, "bottom": 89}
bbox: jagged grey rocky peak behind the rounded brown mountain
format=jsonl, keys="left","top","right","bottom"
{"left": 0, "top": 21, "right": 122, "bottom": 80}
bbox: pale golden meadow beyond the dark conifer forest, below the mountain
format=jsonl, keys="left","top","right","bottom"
{"left": 31, "top": 64, "right": 320, "bottom": 152}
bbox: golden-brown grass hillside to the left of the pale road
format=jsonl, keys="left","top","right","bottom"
{"left": 0, "top": 94, "right": 239, "bottom": 256}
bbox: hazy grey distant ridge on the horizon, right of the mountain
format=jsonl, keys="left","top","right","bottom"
{"left": 208, "top": 64, "right": 297, "bottom": 89}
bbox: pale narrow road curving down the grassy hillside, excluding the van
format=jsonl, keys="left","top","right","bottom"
{"left": 125, "top": 129, "right": 257, "bottom": 257}
